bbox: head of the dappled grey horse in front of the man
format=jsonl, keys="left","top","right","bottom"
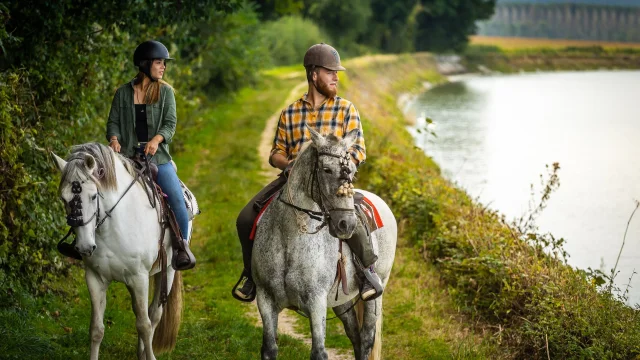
{"left": 307, "top": 127, "right": 359, "bottom": 239}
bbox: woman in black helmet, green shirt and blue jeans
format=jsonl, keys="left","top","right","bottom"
{"left": 107, "top": 41, "right": 195, "bottom": 270}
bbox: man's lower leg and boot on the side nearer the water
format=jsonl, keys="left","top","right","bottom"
{"left": 347, "top": 211, "right": 384, "bottom": 301}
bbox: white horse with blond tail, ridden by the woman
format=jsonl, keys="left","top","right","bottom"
{"left": 52, "top": 143, "right": 184, "bottom": 360}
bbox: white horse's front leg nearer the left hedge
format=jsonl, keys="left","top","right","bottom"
{"left": 84, "top": 267, "right": 108, "bottom": 360}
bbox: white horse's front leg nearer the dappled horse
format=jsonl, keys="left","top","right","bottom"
{"left": 127, "top": 274, "right": 155, "bottom": 360}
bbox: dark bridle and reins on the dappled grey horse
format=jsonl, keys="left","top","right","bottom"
{"left": 278, "top": 151, "right": 355, "bottom": 234}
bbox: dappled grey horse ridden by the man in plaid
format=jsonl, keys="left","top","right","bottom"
{"left": 252, "top": 129, "right": 397, "bottom": 359}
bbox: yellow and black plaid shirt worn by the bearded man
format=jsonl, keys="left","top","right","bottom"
{"left": 269, "top": 94, "right": 367, "bottom": 166}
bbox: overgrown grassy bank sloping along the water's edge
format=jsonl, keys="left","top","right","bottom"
{"left": 348, "top": 55, "right": 640, "bottom": 358}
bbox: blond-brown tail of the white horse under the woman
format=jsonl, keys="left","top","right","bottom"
{"left": 153, "top": 271, "right": 182, "bottom": 354}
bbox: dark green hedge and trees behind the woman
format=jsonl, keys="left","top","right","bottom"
{"left": 0, "top": 0, "right": 268, "bottom": 291}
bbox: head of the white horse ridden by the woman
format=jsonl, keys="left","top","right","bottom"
{"left": 51, "top": 143, "right": 115, "bottom": 257}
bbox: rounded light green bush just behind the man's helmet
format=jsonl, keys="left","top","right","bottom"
{"left": 261, "top": 16, "right": 331, "bottom": 66}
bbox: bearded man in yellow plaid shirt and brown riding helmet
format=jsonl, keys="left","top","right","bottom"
{"left": 232, "top": 43, "right": 382, "bottom": 302}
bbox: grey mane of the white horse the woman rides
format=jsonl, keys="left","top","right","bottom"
{"left": 60, "top": 142, "right": 135, "bottom": 190}
